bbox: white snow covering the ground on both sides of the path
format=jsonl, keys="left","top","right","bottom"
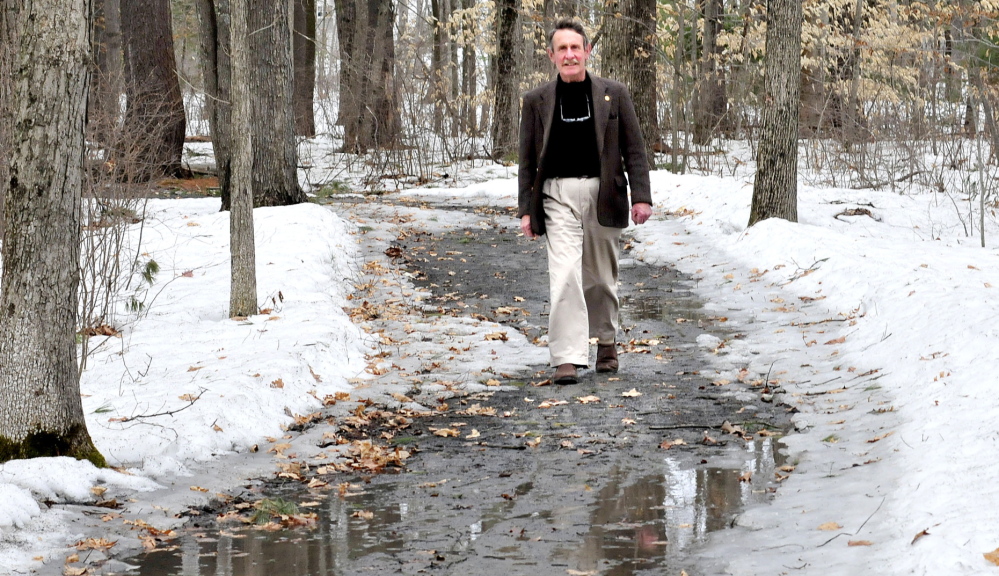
{"left": 0, "top": 146, "right": 999, "bottom": 576}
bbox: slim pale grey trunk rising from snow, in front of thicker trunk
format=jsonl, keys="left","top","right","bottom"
{"left": 229, "top": 0, "right": 256, "bottom": 317}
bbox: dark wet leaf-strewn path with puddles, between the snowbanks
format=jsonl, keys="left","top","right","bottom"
{"left": 119, "top": 196, "right": 788, "bottom": 576}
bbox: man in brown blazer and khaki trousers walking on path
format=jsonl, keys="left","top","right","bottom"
{"left": 517, "top": 18, "right": 652, "bottom": 384}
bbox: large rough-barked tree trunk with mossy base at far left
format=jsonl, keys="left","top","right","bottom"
{"left": 0, "top": 0, "right": 106, "bottom": 466}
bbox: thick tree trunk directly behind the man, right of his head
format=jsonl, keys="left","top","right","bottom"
{"left": 600, "top": 0, "right": 662, "bottom": 162}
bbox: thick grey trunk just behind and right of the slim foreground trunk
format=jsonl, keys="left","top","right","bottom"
{"left": 245, "top": 0, "right": 308, "bottom": 206}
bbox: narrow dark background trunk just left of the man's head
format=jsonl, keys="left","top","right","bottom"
{"left": 491, "top": 0, "right": 520, "bottom": 161}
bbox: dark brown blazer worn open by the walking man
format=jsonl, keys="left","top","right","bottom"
{"left": 517, "top": 72, "right": 652, "bottom": 235}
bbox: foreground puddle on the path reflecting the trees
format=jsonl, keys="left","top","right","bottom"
{"left": 129, "top": 437, "right": 781, "bottom": 576}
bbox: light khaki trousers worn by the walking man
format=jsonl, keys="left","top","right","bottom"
{"left": 544, "top": 178, "right": 621, "bottom": 366}
